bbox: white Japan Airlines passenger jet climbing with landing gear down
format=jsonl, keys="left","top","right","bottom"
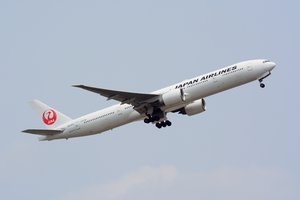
{"left": 22, "top": 59, "right": 276, "bottom": 141}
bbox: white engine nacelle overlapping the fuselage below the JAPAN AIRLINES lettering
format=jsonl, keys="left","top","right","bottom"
{"left": 161, "top": 89, "right": 185, "bottom": 107}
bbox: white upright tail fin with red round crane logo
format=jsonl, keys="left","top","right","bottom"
{"left": 30, "top": 100, "right": 72, "bottom": 129}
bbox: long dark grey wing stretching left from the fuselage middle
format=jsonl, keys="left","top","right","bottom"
{"left": 73, "top": 85, "right": 160, "bottom": 112}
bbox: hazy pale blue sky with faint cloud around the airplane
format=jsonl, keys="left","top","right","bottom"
{"left": 0, "top": 0, "right": 300, "bottom": 200}
